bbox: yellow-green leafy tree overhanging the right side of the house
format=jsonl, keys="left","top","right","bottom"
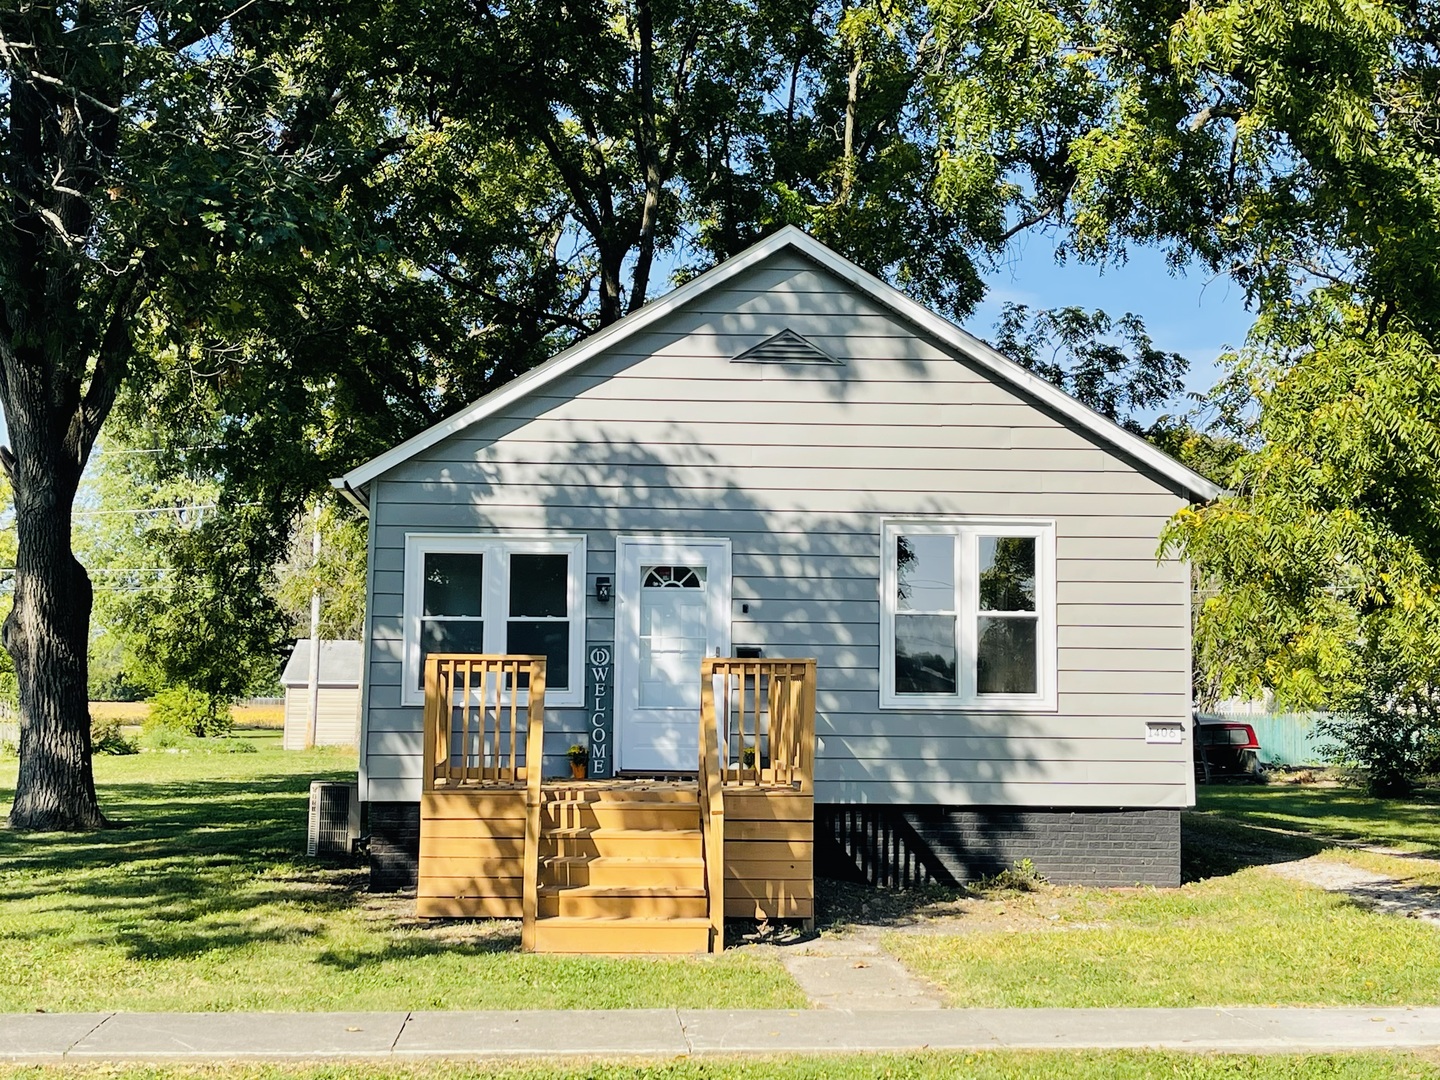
{"left": 950, "top": 0, "right": 1440, "bottom": 789}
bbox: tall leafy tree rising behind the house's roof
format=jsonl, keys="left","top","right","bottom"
{"left": 121, "top": 0, "right": 1203, "bottom": 737}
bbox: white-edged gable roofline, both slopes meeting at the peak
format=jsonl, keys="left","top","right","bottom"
{"left": 330, "top": 225, "right": 1224, "bottom": 505}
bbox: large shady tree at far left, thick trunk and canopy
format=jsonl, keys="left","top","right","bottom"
{"left": 0, "top": 0, "right": 355, "bottom": 829}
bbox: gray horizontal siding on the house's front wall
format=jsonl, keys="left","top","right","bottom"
{"left": 364, "top": 255, "right": 1192, "bottom": 808}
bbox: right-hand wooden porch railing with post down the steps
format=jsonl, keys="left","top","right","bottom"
{"left": 698, "top": 658, "right": 815, "bottom": 952}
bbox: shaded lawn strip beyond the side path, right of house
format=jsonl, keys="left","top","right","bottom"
{"left": 1197, "top": 783, "right": 1440, "bottom": 855}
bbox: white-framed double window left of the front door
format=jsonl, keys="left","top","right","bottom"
{"left": 403, "top": 534, "right": 585, "bottom": 706}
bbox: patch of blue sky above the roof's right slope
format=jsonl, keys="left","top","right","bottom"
{"left": 965, "top": 233, "right": 1251, "bottom": 417}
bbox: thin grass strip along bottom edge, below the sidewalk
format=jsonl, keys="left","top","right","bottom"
{"left": 8, "top": 1050, "right": 1440, "bottom": 1080}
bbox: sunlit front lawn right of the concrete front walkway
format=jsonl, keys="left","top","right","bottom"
{"left": 884, "top": 815, "right": 1440, "bottom": 1007}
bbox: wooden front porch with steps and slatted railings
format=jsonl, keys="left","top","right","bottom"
{"left": 416, "top": 655, "right": 815, "bottom": 952}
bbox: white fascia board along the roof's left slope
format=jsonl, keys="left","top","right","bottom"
{"left": 331, "top": 233, "right": 809, "bottom": 490}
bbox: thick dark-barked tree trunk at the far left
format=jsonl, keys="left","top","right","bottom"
{"left": 0, "top": 4, "right": 125, "bottom": 829}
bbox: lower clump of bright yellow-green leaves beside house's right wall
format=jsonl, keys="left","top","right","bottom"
{"left": 1165, "top": 304, "right": 1440, "bottom": 722}
